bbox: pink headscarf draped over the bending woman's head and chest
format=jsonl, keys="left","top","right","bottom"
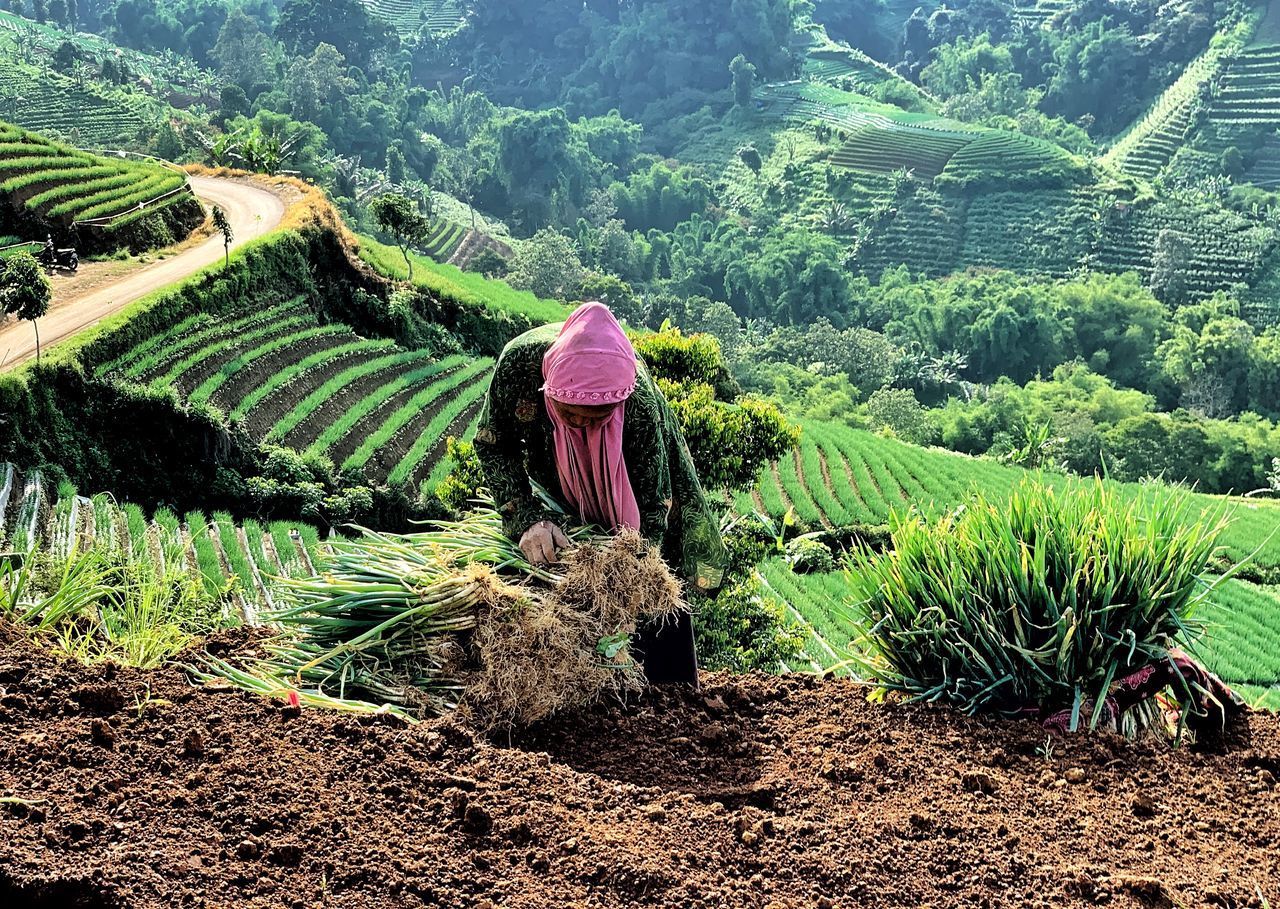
{"left": 543, "top": 302, "right": 640, "bottom": 530}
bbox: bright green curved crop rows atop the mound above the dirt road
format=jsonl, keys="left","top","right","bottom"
{"left": 0, "top": 123, "right": 192, "bottom": 236}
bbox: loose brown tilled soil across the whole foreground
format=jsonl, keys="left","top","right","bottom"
{"left": 0, "top": 627, "right": 1280, "bottom": 909}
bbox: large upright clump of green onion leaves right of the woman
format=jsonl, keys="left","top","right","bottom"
{"left": 847, "top": 480, "right": 1226, "bottom": 726}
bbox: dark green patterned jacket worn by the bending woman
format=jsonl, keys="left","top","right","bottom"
{"left": 475, "top": 324, "right": 728, "bottom": 593}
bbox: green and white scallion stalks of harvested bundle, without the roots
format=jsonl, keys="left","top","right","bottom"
{"left": 196, "top": 504, "right": 609, "bottom": 714}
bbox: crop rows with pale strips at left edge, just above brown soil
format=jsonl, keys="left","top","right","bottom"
{"left": 0, "top": 462, "right": 324, "bottom": 622}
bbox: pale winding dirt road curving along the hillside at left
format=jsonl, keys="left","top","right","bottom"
{"left": 0, "top": 177, "right": 285, "bottom": 370}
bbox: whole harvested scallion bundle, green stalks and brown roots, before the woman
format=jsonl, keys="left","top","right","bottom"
{"left": 193, "top": 508, "right": 685, "bottom": 723}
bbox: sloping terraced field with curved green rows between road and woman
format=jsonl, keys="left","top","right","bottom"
{"left": 97, "top": 298, "right": 493, "bottom": 488}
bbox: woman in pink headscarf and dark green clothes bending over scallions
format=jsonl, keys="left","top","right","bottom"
{"left": 475, "top": 302, "right": 727, "bottom": 685}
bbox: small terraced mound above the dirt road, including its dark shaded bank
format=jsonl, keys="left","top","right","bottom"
{"left": 0, "top": 123, "right": 204, "bottom": 250}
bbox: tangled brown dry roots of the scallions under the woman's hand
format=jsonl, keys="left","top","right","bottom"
{"left": 463, "top": 531, "right": 687, "bottom": 726}
